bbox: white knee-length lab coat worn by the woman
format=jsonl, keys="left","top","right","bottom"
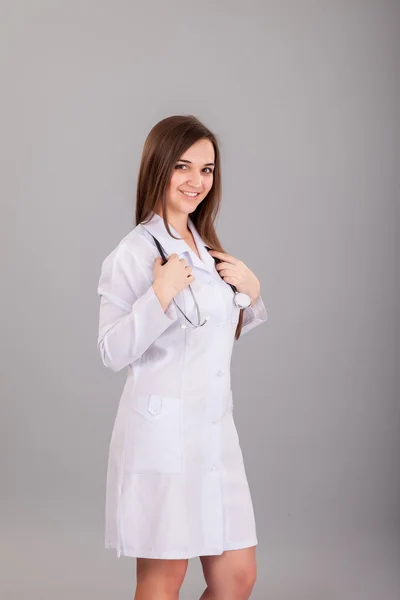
{"left": 98, "top": 213, "right": 267, "bottom": 559}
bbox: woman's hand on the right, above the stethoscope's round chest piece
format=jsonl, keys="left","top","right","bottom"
{"left": 209, "top": 250, "right": 260, "bottom": 304}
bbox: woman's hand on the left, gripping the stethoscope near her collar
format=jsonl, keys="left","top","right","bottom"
{"left": 153, "top": 253, "right": 194, "bottom": 311}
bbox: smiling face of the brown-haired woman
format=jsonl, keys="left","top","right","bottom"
{"left": 167, "top": 139, "right": 215, "bottom": 215}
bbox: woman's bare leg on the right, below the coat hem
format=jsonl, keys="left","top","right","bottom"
{"left": 200, "top": 546, "right": 257, "bottom": 600}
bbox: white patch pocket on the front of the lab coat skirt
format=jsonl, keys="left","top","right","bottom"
{"left": 125, "top": 394, "right": 183, "bottom": 473}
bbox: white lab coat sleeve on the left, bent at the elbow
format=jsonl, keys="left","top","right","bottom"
{"left": 97, "top": 246, "right": 177, "bottom": 371}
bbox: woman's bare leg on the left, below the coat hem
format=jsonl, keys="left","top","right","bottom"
{"left": 134, "top": 558, "right": 188, "bottom": 600}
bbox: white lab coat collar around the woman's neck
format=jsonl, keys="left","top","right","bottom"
{"left": 141, "top": 212, "right": 215, "bottom": 272}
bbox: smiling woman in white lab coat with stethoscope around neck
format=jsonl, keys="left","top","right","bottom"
{"left": 98, "top": 116, "right": 267, "bottom": 600}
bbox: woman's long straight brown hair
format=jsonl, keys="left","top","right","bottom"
{"left": 135, "top": 115, "right": 243, "bottom": 339}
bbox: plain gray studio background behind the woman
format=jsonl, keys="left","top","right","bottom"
{"left": 0, "top": 0, "right": 400, "bottom": 600}
